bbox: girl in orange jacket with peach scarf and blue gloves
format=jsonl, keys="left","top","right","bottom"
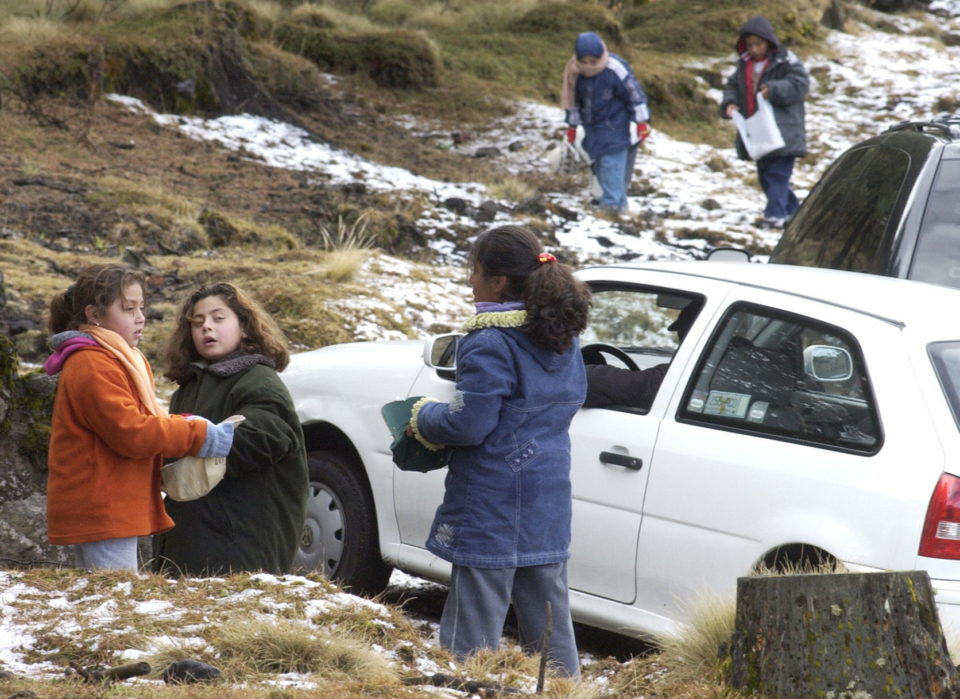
{"left": 44, "top": 264, "right": 233, "bottom": 571}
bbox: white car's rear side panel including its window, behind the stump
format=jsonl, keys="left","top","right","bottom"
{"left": 635, "top": 288, "right": 943, "bottom": 632}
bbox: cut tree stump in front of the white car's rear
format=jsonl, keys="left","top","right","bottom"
{"left": 730, "top": 571, "right": 960, "bottom": 698}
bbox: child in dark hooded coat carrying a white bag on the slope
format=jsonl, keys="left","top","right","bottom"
{"left": 720, "top": 16, "right": 810, "bottom": 228}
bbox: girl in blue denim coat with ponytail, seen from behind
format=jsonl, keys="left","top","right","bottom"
{"left": 410, "top": 226, "right": 590, "bottom": 676}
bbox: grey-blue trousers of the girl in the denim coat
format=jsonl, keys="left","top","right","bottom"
{"left": 440, "top": 561, "right": 580, "bottom": 677}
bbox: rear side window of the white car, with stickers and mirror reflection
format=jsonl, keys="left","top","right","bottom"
{"left": 678, "top": 304, "right": 880, "bottom": 453}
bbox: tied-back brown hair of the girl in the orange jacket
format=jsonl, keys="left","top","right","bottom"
{"left": 48, "top": 262, "right": 147, "bottom": 334}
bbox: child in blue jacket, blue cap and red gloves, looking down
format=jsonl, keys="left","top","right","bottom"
{"left": 560, "top": 32, "right": 650, "bottom": 211}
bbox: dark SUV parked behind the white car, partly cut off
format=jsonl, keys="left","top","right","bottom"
{"left": 770, "top": 116, "right": 960, "bottom": 287}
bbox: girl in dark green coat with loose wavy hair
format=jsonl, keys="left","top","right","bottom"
{"left": 154, "top": 282, "right": 308, "bottom": 575}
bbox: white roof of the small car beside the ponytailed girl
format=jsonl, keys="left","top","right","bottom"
{"left": 582, "top": 260, "right": 960, "bottom": 327}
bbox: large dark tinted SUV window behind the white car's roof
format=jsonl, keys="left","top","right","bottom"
{"left": 771, "top": 146, "right": 910, "bottom": 274}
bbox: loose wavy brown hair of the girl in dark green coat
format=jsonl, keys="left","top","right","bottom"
{"left": 164, "top": 282, "right": 290, "bottom": 383}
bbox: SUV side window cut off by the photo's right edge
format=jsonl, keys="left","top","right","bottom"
{"left": 908, "top": 160, "right": 960, "bottom": 287}
